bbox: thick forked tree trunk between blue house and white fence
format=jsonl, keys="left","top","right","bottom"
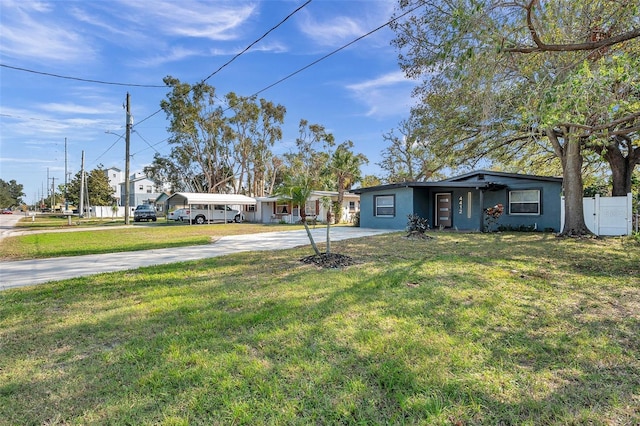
{"left": 546, "top": 129, "right": 591, "bottom": 236}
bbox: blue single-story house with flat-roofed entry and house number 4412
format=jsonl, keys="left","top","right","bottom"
{"left": 352, "top": 170, "right": 562, "bottom": 232}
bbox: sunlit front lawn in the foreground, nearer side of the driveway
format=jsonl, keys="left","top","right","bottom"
{"left": 0, "top": 233, "right": 640, "bottom": 425}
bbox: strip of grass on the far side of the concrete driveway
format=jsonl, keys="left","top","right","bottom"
{"left": 0, "top": 219, "right": 302, "bottom": 260}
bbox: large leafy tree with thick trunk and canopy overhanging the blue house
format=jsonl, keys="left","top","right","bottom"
{"left": 394, "top": 0, "right": 640, "bottom": 235}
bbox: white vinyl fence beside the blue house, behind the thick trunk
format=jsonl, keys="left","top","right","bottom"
{"left": 560, "top": 193, "right": 633, "bottom": 235}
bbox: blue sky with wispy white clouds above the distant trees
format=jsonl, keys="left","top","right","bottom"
{"left": 0, "top": 0, "right": 415, "bottom": 203}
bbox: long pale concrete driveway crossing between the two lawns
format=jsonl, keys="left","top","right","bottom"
{"left": 0, "top": 226, "right": 396, "bottom": 290}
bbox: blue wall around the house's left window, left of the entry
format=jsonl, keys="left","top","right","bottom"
{"left": 360, "top": 187, "right": 414, "bottom": 229}
